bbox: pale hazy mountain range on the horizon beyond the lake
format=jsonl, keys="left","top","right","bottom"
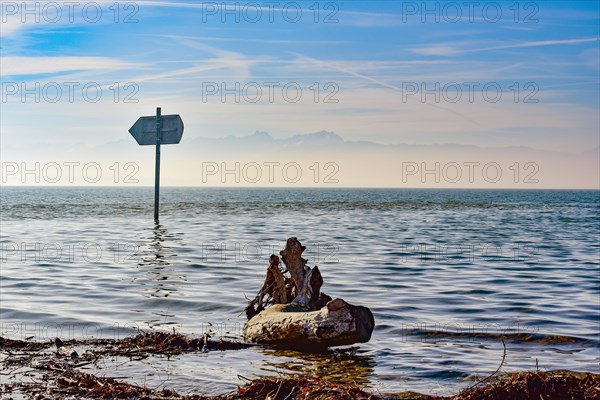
{"left": 2, "top": 130, "right": 600, "bottom": 189}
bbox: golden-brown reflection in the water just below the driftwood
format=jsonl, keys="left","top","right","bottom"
{"left": 263, "top": 347, "right": 375, "bottom": 387}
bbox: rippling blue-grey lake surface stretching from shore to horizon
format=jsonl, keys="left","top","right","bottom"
{"left": 0, "top": 187, "right": 600, "bottom": 394}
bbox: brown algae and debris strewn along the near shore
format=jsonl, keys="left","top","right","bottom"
{"left": 0, "top": 332, "right": 600, "bottom": 400}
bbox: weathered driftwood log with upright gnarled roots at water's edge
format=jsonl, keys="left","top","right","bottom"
{"left": 244, "top": 237, "right": 375, "bottom": 347}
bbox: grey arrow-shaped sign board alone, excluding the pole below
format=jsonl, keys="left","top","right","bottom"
{"left": 129, "top": 114, "right": 183, "bottom": 146}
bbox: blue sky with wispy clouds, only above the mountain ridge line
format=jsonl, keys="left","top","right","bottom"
{"left": 0, "top": 0, "right": 600, "bottom": 188}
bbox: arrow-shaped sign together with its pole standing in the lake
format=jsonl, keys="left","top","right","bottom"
{"left": 129, "top": 107, "right": 183, "bottom": 222}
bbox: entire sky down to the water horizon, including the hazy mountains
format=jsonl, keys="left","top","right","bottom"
{"left": 0, "top": 0, "right": 600, "bottom": 189}
